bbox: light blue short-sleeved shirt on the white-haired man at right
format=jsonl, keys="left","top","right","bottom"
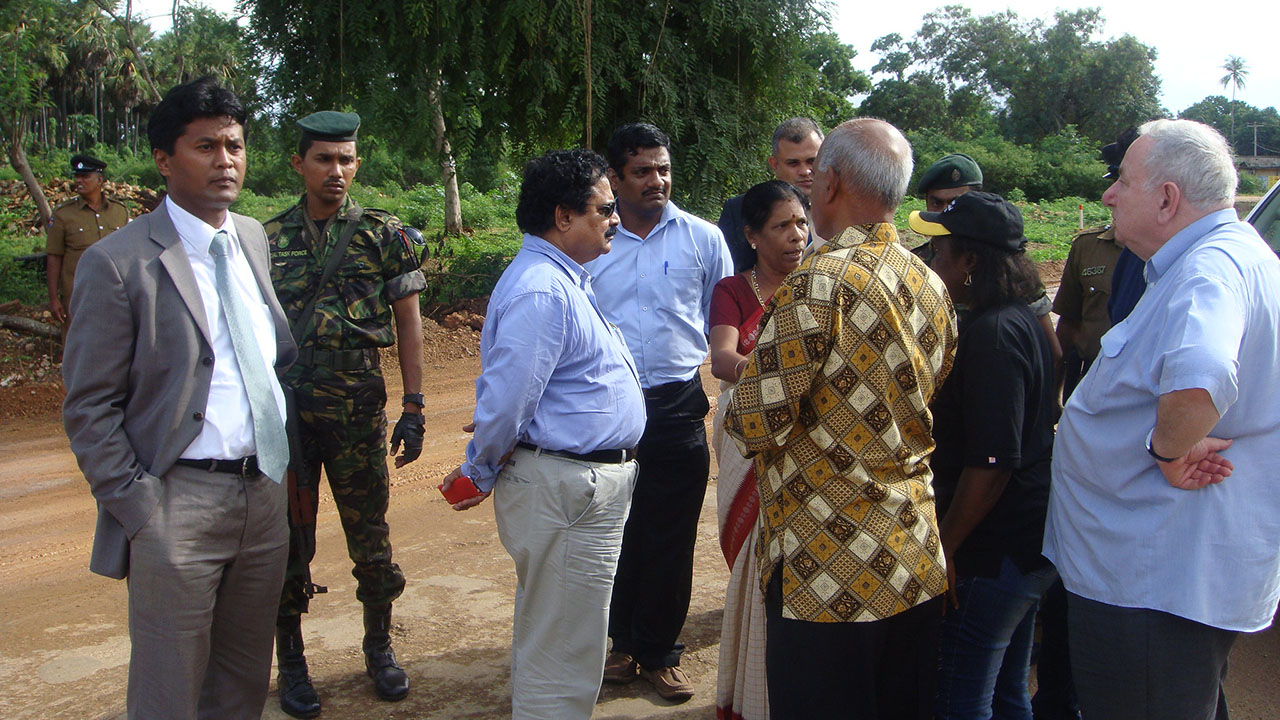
{"left": 1044, "top": 210, "right": 1280, "bottom": 632}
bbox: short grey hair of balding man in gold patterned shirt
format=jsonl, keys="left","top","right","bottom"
{"left": 818, "top": 118, "right": 914, "bottom": 209}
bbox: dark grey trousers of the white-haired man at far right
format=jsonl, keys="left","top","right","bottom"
{"left": 1066, "top": 592, "right": 1236, "bottom": 720}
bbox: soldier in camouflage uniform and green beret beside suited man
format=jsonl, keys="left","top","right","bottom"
{"left": 265, "top": 111, "right": 426, "bottom": 717}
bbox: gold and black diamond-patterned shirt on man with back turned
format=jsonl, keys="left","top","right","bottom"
{"left": 726, "top": 223, "right": 956, "bottom": 623}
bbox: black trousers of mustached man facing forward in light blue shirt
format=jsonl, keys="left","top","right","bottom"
{"left": 609, "top": 375, "right": 710, "bottom": 670}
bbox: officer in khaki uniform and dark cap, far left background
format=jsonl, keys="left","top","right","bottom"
{"left": 45, "top": 155, "right": 129, "bottom": 327}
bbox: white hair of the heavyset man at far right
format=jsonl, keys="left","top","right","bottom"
{"left": 1138, "top": 120, "right": 1239, "bottom": 210}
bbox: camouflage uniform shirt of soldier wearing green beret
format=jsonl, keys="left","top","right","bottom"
{"left": 265, "top": 195, "right": 426, "bottom": 361}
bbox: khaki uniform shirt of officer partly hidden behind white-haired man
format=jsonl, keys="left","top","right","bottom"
{"left": 1053, "top": 227, "right": 1124, "bottom": 360}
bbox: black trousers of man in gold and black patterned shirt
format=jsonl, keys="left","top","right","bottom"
{"left": 764, "top": 569, "right": 942, "bottom": 720}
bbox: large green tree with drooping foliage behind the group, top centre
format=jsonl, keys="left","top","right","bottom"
{"left": 251, "top": 0, "right": 867, "bottom": 221}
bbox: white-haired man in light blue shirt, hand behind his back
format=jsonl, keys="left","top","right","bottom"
{"left": 1044, "top": 120, "right": 1280, "bottom": 720}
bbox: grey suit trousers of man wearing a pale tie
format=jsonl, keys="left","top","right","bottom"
{"left": 127, "top": 466, "right": 289, "bottom": 720}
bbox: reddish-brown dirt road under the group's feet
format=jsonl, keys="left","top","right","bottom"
{"left": 0, "top": 338, "right": 1280, "bottom": 720}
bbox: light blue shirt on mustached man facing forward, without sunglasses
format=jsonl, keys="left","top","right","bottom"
{"left": 586, "top": 202, "right": 733, "bottom": 389}
